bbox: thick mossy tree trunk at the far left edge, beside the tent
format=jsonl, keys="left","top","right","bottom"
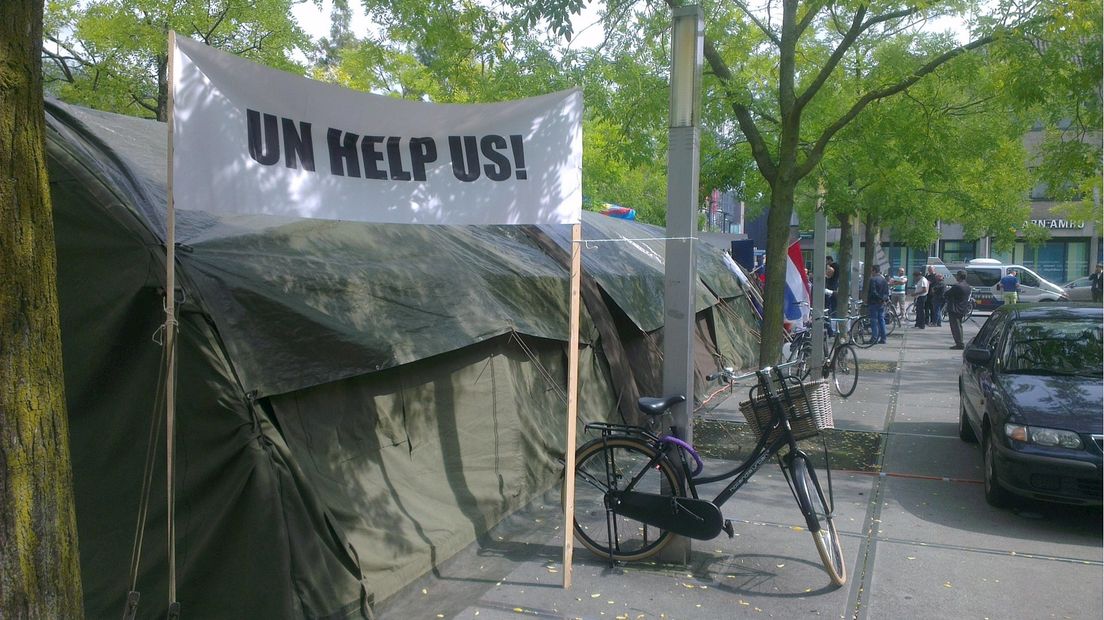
{"left": 0, "top": 0, "right": 84, "bottom": 619}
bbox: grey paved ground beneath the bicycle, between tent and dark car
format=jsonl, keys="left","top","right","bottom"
{"left": 376, "top": 317, "right": 1104, "bottom": 620}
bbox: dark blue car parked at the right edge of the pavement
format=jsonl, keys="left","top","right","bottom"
{"left": 958, "top": 302, "right": 1104, "bottom": 506}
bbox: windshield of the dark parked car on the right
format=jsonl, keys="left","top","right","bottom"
{"left": 1001, "top": 319, "right": 1104, "bottom": 377}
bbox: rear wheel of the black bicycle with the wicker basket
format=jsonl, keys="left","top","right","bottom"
{"left": 561, "top": 437, "right": 681, "bottom": 562}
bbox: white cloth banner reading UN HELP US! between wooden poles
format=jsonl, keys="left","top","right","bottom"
{"left": 172, "top": 36, "right": 583, "bottom": 224}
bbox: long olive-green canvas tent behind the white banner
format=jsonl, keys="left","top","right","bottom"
{"left": 46, "top": 101, "right": 757, "bottom": 618}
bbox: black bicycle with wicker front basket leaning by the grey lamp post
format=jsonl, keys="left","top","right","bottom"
{"left": 560, "top": 366, "right": 847, "bottom": 586}
